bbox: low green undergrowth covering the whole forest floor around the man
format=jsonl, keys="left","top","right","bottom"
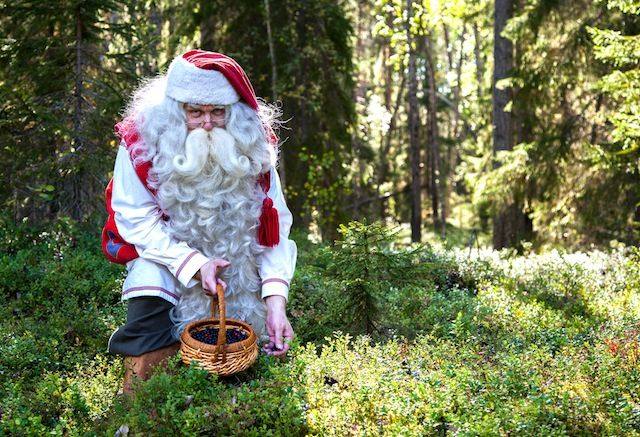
{"left": 0, "top": 216, "right": 640, "bottom": 436}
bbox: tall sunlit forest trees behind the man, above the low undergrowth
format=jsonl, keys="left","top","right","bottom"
{"left": 0, "top": 0, "right": 640, "bottom": 249}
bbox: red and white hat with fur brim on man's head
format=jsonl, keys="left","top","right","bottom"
{"left": 166, "top": 50, "right": 258, "bottom": 110}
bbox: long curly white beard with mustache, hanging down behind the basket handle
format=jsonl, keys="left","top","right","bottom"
{"left": 153, "top": 128, "right": 268, "bottom": 339}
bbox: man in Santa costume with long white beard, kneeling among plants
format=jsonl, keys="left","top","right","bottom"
{"left": 102, "top": 50, "right": 296, "bottom": 391}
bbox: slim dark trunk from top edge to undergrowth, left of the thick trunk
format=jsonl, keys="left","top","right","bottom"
{"left": 406, "top": 0, "right": 422, "bottom": 242}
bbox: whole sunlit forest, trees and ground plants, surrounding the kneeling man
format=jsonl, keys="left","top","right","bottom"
{"left": 0, "top": 0, "right": 640, "bottom": 435}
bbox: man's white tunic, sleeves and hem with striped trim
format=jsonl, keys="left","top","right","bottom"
{"left": 111, "top": 145, "right": 297, "bottom": 305}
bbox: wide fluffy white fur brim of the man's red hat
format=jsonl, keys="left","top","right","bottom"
{"left": 166, "top": 51, "right": 240, "bottom": 105}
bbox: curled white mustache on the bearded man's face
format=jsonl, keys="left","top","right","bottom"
{"left": 173, "top": 128, "right": 251, "bottom": 178}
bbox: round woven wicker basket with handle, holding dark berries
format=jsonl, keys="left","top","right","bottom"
{"left": 180, "top": 284, "right": 258, "bottom": 376}
